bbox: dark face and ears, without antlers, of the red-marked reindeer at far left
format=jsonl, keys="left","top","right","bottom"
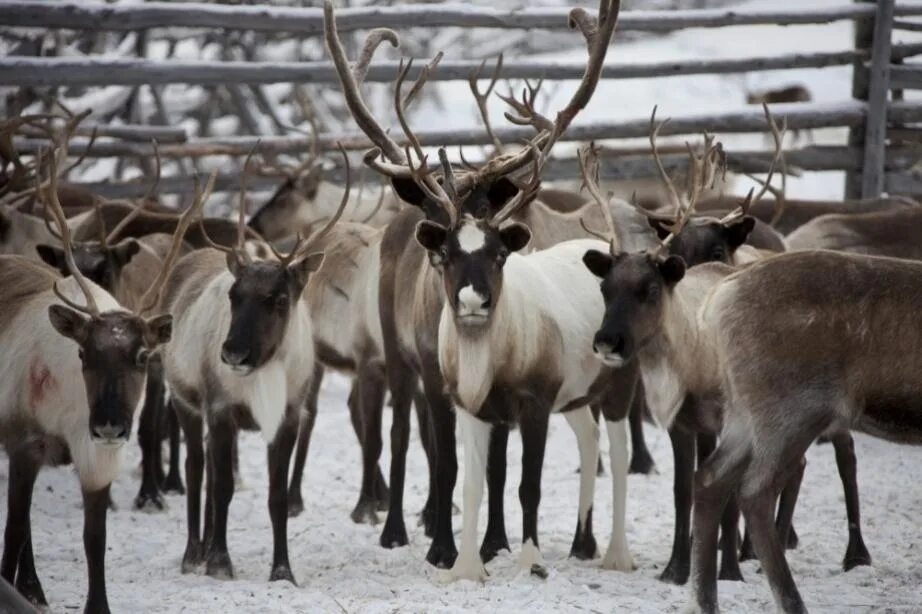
{"left": 48, "top": 305, "right": 173, "bottom": 445}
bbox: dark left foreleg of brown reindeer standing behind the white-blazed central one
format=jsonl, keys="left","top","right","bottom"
{"left": 380, "top": 364, "right": 416, "bottom": 548}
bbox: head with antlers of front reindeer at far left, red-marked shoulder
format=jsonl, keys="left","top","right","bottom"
{"left": 36, "top": 130, "right": 203, "bottom": 445}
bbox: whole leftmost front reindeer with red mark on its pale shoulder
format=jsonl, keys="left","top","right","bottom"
{"left": 0, "top": 145, "right": 202, "bottom": 612}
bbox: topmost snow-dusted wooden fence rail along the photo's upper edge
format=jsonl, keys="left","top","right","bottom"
{"left": 0, "top": 0, "right": 922, "bottom": 36}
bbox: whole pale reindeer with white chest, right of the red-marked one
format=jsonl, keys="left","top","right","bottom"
{"left": 162, "top": 147, "right": 348, "bottom": 583}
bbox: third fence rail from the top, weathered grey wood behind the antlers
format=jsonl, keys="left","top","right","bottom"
{"left": 15, "top": 100, "right": 922, "bottom": 158}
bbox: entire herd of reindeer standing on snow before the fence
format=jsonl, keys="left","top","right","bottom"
{"left": 0, "top": 0, "right": 922, "bottom": 612}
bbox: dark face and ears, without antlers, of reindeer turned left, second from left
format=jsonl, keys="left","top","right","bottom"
{"left": 221, "top": 253, "right": 323, "bottom": 375}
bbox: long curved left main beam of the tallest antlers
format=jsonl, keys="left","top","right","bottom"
{"left": 323, "top": 0, "right": 406, "bottom": 164}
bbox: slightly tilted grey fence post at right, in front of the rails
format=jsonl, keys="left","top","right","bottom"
{"left": 861, "top": 0, "right": 895, "bottom": 198}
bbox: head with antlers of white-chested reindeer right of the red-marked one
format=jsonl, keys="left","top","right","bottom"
{"left": 201, "top": 145, "right": 351, "bottom": 375}
